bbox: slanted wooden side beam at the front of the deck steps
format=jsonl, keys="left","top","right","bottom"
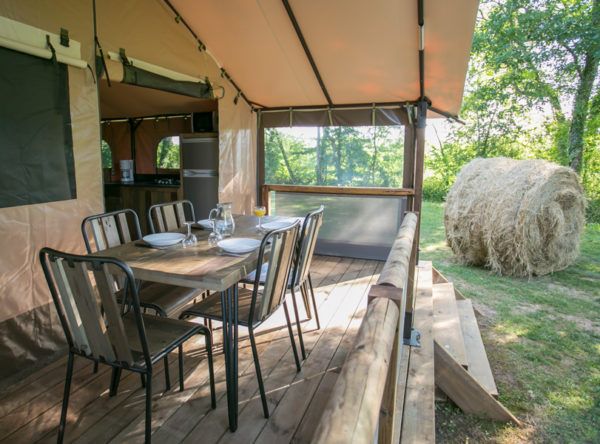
{"left": 434, "top": 341, "right": 521, "bottom": 426}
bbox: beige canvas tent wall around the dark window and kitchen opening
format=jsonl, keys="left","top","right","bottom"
{"left": 0, "top": 0, "right": 256, "bottom": 381}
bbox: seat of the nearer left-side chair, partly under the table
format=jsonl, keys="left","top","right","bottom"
{"left": 117, "top": 281, "right": 203, "bottom": 316}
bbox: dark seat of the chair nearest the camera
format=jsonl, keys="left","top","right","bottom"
{"left": 123, "top": 312, "right": 210, "bottom": 366}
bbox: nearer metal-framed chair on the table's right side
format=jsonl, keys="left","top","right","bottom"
{"left": 181, "top": 222, "right": 300, "bottom": 418}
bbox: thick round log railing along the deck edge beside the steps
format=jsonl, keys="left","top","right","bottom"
{"left": 313, "top": 213, "right": 418, "bottom": 444}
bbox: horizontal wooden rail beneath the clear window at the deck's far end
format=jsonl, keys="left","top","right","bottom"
{"left": 261, "top": 184, "right": 415, "bottom": 211}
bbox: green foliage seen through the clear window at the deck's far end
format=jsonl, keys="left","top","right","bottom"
{"left": 265, "top": 126, "right": 403, "bottom": 187}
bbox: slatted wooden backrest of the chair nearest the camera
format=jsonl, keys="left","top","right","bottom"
{"left": 40, "top": 248, "right": 150, "bottom": 366}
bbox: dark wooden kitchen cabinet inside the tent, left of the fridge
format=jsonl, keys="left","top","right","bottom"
{"left": 104, "top": 183, "right": 181, "bottom": 234}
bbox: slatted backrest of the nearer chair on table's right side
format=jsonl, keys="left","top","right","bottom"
{"left": 249, "top": 222, "right": 300, "bottom": 323}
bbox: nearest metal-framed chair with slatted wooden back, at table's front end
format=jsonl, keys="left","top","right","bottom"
{"left": 39, "top": 248, "right": 216, "bottom": 443}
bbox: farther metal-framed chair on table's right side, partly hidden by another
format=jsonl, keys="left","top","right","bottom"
{"left": 242, "top": 205, "right": 324, "bottom": 359}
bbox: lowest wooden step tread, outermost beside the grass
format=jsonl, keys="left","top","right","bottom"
{"left": 456, "top": 299, "right": 498, "bottom": 398}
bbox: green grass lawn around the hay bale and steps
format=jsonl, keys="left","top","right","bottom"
{"left": 421, "top": 202, "right": 600, "bottom": 443}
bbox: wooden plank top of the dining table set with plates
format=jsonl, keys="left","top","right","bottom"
{"left": 94, "top": 216, "right": 278, "bottom": 291}
